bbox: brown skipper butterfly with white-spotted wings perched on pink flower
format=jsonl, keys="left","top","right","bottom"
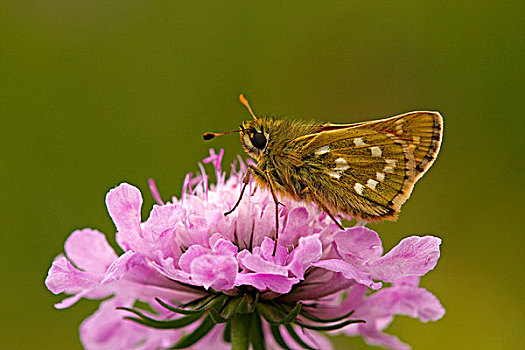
{"left": 203, "top": 95, "right": 443, "bottom": 249}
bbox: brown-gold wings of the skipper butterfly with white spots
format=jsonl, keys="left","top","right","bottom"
{"left": 292, "top": 112, "right": 442, "bottom": 220}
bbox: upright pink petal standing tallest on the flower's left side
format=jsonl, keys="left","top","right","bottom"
{"left": 106, "top": 183, "right": 143, "bottom": 251}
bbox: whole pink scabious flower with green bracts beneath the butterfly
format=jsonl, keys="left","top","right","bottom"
{"left": 46, "top": 150, "right": 445, "bottom": 349}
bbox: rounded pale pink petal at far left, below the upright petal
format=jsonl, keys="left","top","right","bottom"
{"left": 64, "top": 228, "right": 117, "bottom": 273}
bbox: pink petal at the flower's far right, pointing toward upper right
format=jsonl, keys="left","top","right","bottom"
{"left": 369, "top": 236, "right": 441, "bottom": 282}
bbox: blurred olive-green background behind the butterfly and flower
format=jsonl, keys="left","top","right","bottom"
{"left": 0, "top": 1, "right": 525, "bottom": 349}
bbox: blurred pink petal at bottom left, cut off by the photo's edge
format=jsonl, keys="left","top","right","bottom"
{"left": 80, "top": 299, "right": 180, "bottom": 350}
